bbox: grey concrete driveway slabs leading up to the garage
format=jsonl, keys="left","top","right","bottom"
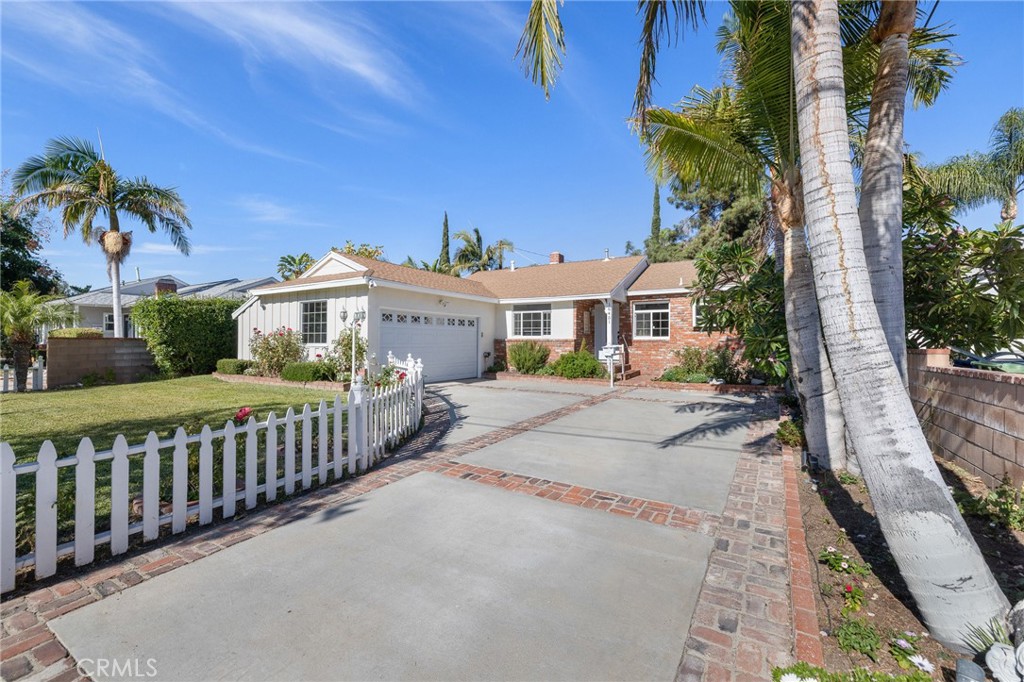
{"left": 50, "top": 382, "right": 765, "bottom": 681}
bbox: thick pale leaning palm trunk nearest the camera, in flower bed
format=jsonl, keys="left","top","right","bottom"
{"left": 792, "top": 0, "right": 1009, "bottom": 651}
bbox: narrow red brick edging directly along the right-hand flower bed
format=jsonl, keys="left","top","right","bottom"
{"left": 782, "top": 447, "right": 824, "bottom": 666}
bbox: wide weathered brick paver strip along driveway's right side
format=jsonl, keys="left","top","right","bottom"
{"left": 676, "top": 398, "right": 794, "bottom": 682}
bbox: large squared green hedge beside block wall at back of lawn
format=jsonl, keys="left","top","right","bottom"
{"left": 131, "top": 296, "right": 239, "bottom": 376}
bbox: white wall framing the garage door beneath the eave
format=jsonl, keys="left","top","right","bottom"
{"left": 367, "top": 283, "right": 497, "bottom": 372}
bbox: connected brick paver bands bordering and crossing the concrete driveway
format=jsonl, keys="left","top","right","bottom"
{"left": 0, "top": 382, "right": 820, "bottom": 682}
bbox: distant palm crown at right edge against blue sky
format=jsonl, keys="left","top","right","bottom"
{"left": 930, "top": 108, "right": 1024, "bottom": 222}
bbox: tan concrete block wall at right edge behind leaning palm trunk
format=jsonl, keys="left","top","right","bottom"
{"left": 907, "top": 348, "right": 1024, "bottom": 487}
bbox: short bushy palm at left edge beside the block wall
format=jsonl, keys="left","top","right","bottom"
{"left": 0, "top": 280, "right": 75, "bottom": 392}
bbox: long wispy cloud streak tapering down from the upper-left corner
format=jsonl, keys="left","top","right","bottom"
{"left": 3, "top": 2, "right": 305, "bottom": 163}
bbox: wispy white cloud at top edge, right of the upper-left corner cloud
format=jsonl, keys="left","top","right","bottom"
{"left": 167, "top": 2, "right": 420, "bottom": 100}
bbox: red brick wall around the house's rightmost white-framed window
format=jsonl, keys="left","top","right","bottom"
{"left": 618, "top": 294, "right": 731, "bottom": 377}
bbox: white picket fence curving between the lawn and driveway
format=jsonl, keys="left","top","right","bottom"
{"left": 0, "top": 354, "right": 423, "bottom": 592}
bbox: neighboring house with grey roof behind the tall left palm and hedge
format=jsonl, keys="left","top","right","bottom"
{"left": 48, "top": 274, "right": 278, "bottom": 335}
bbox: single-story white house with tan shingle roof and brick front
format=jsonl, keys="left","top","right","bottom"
{"left": 234, "top": 251, "right": 725, "bottom": 381}
